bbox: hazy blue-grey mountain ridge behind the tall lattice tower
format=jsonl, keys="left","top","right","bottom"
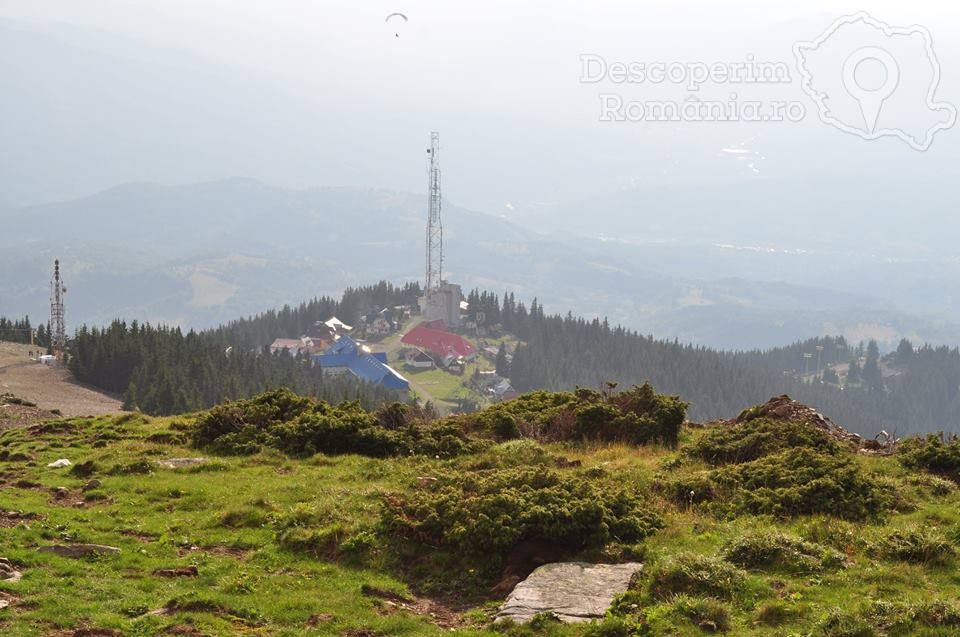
{"left": 0, "top": 179, "right": 960, "bottom": 349}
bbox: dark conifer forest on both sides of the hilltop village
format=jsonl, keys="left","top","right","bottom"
{"left": 58, "top": 282, "right": 960, "bottom": 436}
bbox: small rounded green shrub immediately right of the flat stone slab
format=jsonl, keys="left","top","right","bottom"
{"left": 648, "top": 553, "right": 747, "bottom": 600}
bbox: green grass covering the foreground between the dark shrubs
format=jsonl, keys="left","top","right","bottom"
{"left": 0, "top": 404, "right": 960, "bottom": 637}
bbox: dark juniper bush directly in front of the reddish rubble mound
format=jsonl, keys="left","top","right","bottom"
{"left": 687, "top": 418, "right": 840, "bottom": 465}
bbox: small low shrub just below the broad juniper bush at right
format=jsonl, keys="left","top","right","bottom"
{"left": 722, "top": 531, "right": 844, "bottom": 574}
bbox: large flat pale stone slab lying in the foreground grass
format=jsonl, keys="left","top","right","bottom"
{"left": 495, "top": 562, "right": 643, "bottom": 623}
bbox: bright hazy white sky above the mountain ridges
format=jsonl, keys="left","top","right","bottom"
{"left": 0, "top": 0, "right": 960, "bottom": 212}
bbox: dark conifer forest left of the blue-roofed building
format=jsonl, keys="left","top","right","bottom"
{"left": 63, "top": 283, "right": 419, "bottom": 414}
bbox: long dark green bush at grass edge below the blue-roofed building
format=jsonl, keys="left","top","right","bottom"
{"left": 191, "top": 390, "right": 482, "bottom": 458}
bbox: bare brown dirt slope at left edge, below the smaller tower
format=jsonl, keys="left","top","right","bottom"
{"left": 0, "top": 341, "right": 123, "bottom": 422}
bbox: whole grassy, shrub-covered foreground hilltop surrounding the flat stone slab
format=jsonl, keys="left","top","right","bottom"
{"left": 0, "top": 386, "right": 960, "bottom": 637}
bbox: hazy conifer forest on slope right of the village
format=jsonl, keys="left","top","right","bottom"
{"left": 510, "top": 304, "right": 960, "bottom": 436}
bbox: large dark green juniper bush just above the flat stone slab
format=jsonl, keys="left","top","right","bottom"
{"left": 381, "top": 467, "right": 662, "bottom": 556}
